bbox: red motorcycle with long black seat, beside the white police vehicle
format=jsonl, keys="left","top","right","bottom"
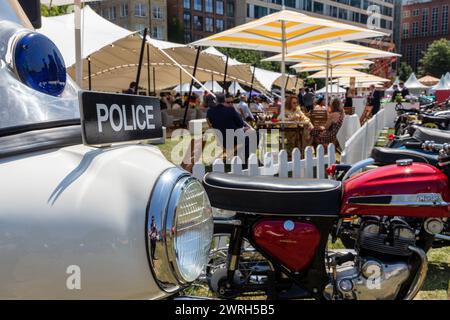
{"left": 203, "top": 144, "right": 450, "bottom": 300}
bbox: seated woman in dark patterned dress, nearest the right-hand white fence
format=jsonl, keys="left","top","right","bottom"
{"left": 311, "top": 99, "right": 344, "bottom": 146}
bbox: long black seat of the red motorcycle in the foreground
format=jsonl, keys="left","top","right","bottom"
{"left": 203, "top": 173, "right": 342, "bottom": 216}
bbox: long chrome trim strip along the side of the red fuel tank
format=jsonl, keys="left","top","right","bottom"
{"left": 347, "top": 193, "right": 450, "bottom": 207}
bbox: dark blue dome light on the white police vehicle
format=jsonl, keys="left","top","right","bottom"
{"left": 14, "top": 33, "right": 66, "bottom": 96}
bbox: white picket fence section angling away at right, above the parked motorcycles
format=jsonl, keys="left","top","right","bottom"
{"left": 341, "top": 109, "right": 392, "bottom": 164}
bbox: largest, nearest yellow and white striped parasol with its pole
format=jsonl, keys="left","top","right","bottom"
{"left": 192, "top": 10, "right": 386, "bottom": 117}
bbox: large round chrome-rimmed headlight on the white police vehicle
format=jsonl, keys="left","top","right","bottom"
{"left": 147, "top": 168, "right": 213, "bottom": 292}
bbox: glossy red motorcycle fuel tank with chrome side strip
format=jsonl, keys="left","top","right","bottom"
{"left": 341, "top": 161, "right": 450, "bottom": 218}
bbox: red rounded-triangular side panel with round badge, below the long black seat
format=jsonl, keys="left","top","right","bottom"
{"left": 253, "top": 219, "right": 320, "bottom": 272}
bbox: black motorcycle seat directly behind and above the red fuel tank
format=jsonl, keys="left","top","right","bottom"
{"left": 371, "top": 147, "right": 438, "bottom": 166}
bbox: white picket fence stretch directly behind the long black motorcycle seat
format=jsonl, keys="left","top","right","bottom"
{"left": 192, "top": 144, "right": 336, "bottom": 180}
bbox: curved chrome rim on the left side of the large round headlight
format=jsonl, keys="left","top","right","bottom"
{"left": 146, "top": 167, "right": 189, "bottom": 293}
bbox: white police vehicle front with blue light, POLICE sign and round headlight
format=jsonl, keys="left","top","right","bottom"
{"left": 0, "top": 0, "right": 213, "bottom": 299}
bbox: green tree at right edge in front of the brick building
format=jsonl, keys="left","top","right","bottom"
{"left": 419, "top": 39, "right": 450, "bottom": 78}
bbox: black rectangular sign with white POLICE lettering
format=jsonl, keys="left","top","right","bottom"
{"left": 80, "top": 91, "right": 163, "bottom": 145}
